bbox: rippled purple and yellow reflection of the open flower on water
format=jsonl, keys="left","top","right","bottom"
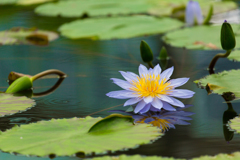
{"left": 111, "top": 105, "right": 194, "bottom": 132}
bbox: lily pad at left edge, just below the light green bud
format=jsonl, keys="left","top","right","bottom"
{"left": 0, "top": 93, "right": 36, "bottom": 117}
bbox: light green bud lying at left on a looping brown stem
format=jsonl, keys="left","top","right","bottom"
{"left": 6, "top": 76, "right": 32, "bottom": 93}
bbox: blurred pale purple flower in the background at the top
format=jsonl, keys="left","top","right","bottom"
{"left": 185, "top": 0, "right": 203, "bottom": 25}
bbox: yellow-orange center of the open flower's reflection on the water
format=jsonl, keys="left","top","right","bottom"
{"left": 136, "top": 116, "right": 170, "bottom": 132}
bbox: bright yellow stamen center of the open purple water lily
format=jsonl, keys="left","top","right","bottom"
{"left": 130, "top": 74, "right": 173, "bottom": 97}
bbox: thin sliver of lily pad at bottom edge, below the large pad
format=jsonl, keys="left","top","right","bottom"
{"left": 89, "top": 155, "right": 184, "bottom": 160}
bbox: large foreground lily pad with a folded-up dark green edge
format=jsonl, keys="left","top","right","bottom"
{"left": 0, "top": 115, "right": 162, "bottom": 156}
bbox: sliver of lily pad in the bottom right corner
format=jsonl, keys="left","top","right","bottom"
{"left": 192, "top": 152, "right": 240, "bottom": 160}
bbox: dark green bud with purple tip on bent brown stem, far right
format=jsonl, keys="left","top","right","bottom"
{"left": 221, "top": 20, "right": 236, "bottom": 51}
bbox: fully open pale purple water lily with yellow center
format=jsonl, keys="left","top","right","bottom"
{"left": 106, "top": 64, "right": 195, "bottom": 113}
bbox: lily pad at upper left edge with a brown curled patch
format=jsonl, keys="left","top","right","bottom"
{"left": 0, "top": 27, "right": 58, "bottom": 45}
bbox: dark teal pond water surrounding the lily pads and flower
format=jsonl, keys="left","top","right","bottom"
{"left": 0, "top": 3, "right": 240, "bottom": 160}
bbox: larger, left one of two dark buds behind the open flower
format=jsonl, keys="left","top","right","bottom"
{"left": 140, "top": 40, "right": 153, "bottom": 63}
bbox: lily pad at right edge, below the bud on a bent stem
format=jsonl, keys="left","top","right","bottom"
{"left": 194, "top": 70, "right": 240, "bottom": 98}
